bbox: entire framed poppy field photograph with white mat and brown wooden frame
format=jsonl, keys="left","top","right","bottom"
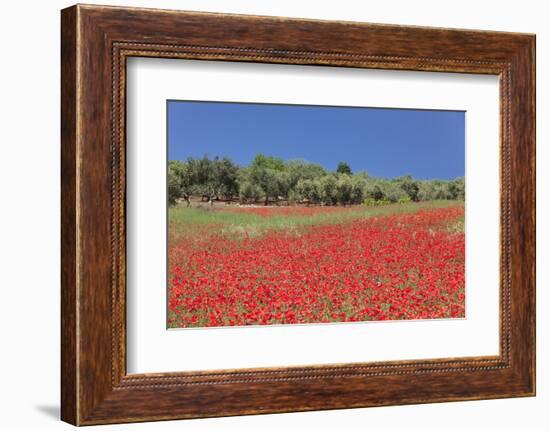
{"left": 61, "top": 5, "right": 535, "bottom": 425}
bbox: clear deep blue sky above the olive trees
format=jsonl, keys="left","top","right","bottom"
{"left": 168, "top": 101, "right": 465, "bottom": 179}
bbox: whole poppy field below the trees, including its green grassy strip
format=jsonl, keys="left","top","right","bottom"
{"left": 168, "top": 201, "right": 465, "bottom": 328}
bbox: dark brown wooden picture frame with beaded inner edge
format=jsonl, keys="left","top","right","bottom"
{"left": 61, "top": 5, "right": 535, "bottom": 425}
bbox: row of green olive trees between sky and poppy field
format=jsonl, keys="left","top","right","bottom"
{"left": 168, "top": 154, "right": 464, "bottom": 205}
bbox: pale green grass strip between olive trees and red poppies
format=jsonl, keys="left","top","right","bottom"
{"left": 168, "top": 200, "right": 462, "bottom": 236}
